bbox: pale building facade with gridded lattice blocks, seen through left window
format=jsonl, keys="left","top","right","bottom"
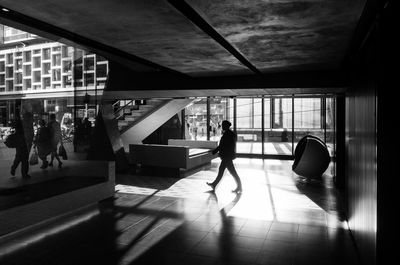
{"left": 0, "top": 25, "right": 108, "bottom": 128}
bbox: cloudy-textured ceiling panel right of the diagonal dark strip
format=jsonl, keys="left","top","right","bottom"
{"left": 187, "top": 0, "right": 365, "bottom": 72}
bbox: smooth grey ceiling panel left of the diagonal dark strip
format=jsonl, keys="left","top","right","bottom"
{"left": 0, "top": 0, "right": 251, "bottom": 76}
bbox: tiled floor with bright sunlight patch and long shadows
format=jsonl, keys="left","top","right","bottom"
{"left": 0, "top": 158, "right": 359, "bottom": 265}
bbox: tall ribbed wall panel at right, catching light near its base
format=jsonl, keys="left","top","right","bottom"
{"left": 346, "top": 83, "right": 377, "bottom": 264}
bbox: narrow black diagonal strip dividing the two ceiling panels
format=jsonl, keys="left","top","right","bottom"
{"left": 168, "top": 0, "right": 261, "bottom": 74}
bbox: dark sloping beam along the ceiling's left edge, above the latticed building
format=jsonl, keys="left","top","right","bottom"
{"left": 0, "top": 6, "right": 189, "bottom": 77}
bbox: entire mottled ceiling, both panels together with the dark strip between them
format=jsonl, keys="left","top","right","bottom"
{"left": 0, "top": 0, "right": 366, "bottom": 77}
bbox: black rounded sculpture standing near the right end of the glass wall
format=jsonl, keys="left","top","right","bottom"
{"left": 292, "top": 135, "right": 331, "bottom": 179}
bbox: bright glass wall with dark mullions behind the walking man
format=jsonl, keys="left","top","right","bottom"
{"left": 185, "top": 95, "right": 336, "bottom": 157}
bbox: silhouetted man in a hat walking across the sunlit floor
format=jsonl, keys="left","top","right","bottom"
{"left": 207, "top": 120, "right": 242, "bottom": 192}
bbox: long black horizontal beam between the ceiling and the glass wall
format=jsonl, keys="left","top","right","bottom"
{"left": 107, "top": 62, "right": 351, "bottom": 90}
